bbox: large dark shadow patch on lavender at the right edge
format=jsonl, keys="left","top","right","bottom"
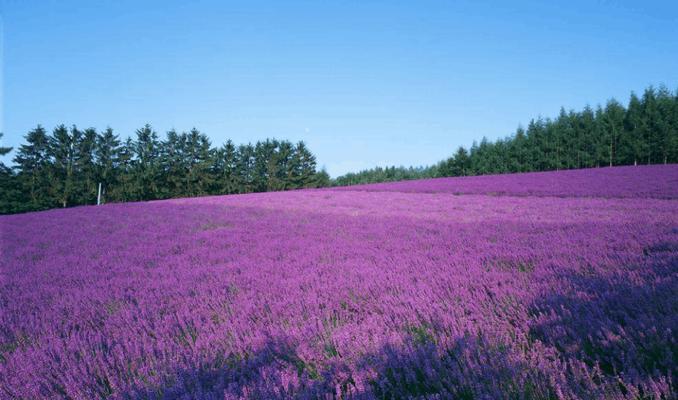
{"left": 528, "top": 253, "right": 678, "bottom": 398}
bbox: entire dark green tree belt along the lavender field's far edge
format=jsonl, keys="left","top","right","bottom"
{"left": 0, "top": 86, "right": 678, "bottom": 214}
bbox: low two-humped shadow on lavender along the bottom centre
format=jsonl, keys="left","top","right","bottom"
{"left": 113, "top": 334, "right": 556, "bottom": 399}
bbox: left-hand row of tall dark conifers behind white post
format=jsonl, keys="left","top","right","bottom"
{"left": 0, "top": 125, "right": 330, "bottom": 213}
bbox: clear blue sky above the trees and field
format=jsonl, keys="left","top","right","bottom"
{"left": 0, "top": 0, "right": 678, "bottom": 176}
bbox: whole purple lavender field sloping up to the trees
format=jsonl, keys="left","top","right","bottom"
{"left": 0, "top": 165, "right": 678, "bottom": 399}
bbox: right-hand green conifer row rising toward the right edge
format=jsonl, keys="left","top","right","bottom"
{"left": 333, "top": 87, "right": 678, "bottom": 186}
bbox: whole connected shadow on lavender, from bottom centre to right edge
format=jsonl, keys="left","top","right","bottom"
{"left": 117, "top": 245, "right": 678, "bottom": 399}
